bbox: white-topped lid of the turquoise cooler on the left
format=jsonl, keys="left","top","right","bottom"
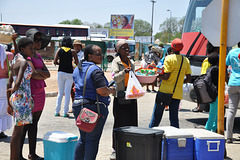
{"left": 43, "top": 131, "right": 78, "bottom": 143}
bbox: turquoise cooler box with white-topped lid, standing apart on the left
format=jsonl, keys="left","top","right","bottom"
{"left": 43, "top": 131, "right": 78, "bottom": 160}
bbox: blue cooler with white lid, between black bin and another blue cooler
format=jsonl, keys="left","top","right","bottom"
{"left": 153, "top": 126, "right": 194, "bottom": 160}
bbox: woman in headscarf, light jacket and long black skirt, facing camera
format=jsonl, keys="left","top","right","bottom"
{"left": 110, "top": 40, "right": 138, "bottom": 159}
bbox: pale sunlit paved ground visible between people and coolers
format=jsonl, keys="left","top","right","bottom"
{"left": 0, "top": 62, "right": 240, "bottom": 160}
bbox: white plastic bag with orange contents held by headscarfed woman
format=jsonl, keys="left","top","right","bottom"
{"left": 125, "top": 71, "right": 145, "bottom": 99}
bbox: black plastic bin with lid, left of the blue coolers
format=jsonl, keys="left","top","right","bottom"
{"left": 113, "top": 126, "right": 164, "bottom": 160}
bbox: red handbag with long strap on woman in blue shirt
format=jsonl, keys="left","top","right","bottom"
{"left": 76, "top": 66, "right": 100, "bottom": 132}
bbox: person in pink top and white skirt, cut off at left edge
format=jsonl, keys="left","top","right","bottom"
{"left": 0, "top": 44, "right": 14, "bottom": 138}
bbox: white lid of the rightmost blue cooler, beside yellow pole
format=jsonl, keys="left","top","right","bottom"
{"left": 182, "top": 128, "right": 224, "bottom": 139}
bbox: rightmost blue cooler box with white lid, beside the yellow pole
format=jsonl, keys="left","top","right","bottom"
{"left": 184, "top": 129, "right": 225, "bottom": 160}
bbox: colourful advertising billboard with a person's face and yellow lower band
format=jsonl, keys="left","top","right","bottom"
{"left": 110, "top": 15, "right": 134, "bottom": 40}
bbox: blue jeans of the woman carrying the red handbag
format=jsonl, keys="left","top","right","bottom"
{"left": 72, "top": 102, "right": 108, "bottom": 160}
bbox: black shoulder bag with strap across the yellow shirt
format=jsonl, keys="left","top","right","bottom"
{"left": 156, "top": 57, "right": 183, "bottom": 106}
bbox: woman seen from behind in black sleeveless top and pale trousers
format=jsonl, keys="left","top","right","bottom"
{"left": 54, "top": 36, "right": 78, "bottom": 117}
